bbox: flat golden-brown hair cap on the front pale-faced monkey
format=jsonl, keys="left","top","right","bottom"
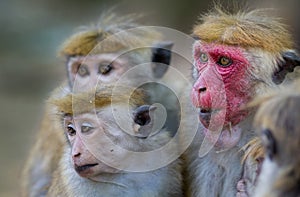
{"left": 48, "top": 86, "right": 147, "bottom": 115}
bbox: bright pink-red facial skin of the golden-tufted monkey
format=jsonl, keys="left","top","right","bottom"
{"left": 191, "top": 42, "right": 251, "bottom": 147}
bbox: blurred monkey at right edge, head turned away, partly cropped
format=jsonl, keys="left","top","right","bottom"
{"left": 254, "top": 80, "right": 300, "bottom": 197}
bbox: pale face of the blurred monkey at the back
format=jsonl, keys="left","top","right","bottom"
{"left": 67, "top": 53, "right": 128, "bottom": 91}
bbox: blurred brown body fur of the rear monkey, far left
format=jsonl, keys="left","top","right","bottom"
{"left": 21, "top": 84, "right": 69, "bottom": 197}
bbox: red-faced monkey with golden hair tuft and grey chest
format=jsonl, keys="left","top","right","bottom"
{"left": 183, "top": 8, "right": 299, "bottom": 197}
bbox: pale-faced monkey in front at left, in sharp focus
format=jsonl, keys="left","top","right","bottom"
{"left": 47, "top": 86, "right": 182, "bottom": 197}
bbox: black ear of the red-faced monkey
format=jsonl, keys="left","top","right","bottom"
{"left": 272, "top": 51, "right": 300, "bottom": 85}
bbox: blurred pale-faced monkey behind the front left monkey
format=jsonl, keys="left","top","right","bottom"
{"left": 21, "top": 12, "right": 174, "bottom": 196}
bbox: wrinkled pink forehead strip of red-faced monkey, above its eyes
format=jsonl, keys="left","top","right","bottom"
{"left": 193, "top": 41, "right": 248, "bottom": 63}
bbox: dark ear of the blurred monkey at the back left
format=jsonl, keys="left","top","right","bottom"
{"left": 151, "top": 41, "right": 173, "bottom": 78}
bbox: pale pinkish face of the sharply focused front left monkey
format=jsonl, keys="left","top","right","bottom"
{"left": 65, "top": 114, "right": 119, "bottom": 178}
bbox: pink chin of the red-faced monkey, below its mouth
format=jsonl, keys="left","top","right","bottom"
{"left": 199, "top": 109, "right": 246, "bottom": 150}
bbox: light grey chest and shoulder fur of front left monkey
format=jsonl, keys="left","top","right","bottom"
{"left": 48, "top": 144, "right": 182, "bottom": 197}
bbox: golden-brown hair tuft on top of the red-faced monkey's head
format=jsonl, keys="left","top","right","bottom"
{"left": 193, "top": 5, "right": 293, "bottom": 53}
